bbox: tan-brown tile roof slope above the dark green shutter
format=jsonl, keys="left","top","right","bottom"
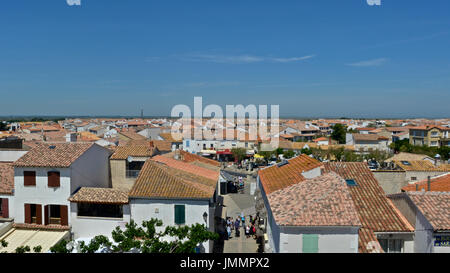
{"left": 129, "top": 159, "right": 217, "bottom": 199}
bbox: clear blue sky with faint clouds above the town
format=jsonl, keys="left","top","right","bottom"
{"left": 0, "top": 0, "right": 450, "bottom": 117}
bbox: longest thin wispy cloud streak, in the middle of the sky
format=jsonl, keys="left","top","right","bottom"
{"left": 183, "top": 54, "right": 315, "bottom": 64}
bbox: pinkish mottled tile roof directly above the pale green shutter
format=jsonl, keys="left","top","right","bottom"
{"left": 268, "top": 172, "right": 361, "bottom": 226}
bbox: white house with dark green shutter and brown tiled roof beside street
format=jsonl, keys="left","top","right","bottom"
{"left": 129, "top": 156, "right": 219, "bottom": 252}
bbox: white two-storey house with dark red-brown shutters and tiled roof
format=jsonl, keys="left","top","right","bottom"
{"left": 10, "top": 143, "right": 111, "bottom": 226}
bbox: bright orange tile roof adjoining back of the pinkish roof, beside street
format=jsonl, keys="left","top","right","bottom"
{"left": 258, "top": 154, "right": 322, "bottom": 195}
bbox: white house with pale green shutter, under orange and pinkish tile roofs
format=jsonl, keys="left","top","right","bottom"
{"left": 258, "top": 155, "right": 361, "bottom": 253}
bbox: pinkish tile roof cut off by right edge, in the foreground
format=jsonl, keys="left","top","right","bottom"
{"left": 407, "top": 191, "right": 450, "bottom": 231}
